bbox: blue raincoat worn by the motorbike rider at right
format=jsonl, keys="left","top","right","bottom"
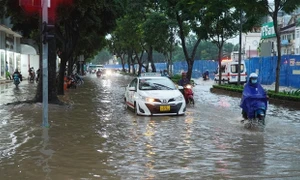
{"left": 240, "top": 82, "right": 268, "bottom": 119}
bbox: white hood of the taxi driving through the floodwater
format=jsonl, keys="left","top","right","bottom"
{"left": 139, "top": 90, "right": 182, "bottom": 99}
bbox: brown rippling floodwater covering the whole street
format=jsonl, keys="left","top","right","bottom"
{"left": 0, "top": 74, "right": 300, "bottom": 180}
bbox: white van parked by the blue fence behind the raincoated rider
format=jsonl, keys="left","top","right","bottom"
{"left": 215, "top": 60, "right": 247, "bottom": 84}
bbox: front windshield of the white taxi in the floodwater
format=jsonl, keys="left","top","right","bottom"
{"left": 139, "top": 78, "right": 176, "bottom": 90}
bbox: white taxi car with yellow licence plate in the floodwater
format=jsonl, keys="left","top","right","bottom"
{"left": 125, "top": 73, "right": 186, "bottom": 116}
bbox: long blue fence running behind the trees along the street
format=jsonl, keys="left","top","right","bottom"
{"left": 105, "top": 55, "right": 300, "bottom": 88}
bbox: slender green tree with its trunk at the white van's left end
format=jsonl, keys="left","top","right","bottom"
{"left": 203, "top": 0, "right": 261, "bottom": 84}
